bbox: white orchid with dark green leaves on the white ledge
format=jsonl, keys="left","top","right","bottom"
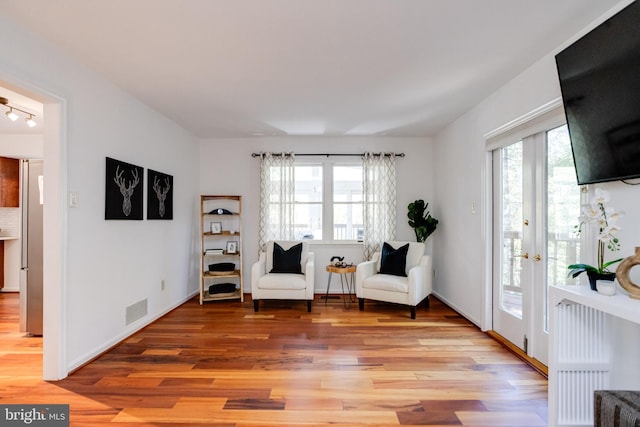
{"left": 568, "top": 188, "right": 623, "bottom": 291}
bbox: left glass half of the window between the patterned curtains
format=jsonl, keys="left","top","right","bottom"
{"left": 294, "top": 165, "right": 322, "bottom": 240}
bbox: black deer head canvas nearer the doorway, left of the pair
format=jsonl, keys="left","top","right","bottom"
{"left": 104, "top": 157, "right": 144, "bottom": 220}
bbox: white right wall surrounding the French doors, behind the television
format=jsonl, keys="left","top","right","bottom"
{"left": 434, "top": 0, "right": 640, "bottom": 326}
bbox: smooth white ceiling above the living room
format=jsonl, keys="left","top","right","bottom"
{"left": 0, "top": 0, "right": 618, "bottom": 138}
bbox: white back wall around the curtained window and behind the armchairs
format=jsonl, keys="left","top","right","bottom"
{"left": 200, "top": 136, "right": 440, "bottom": 293}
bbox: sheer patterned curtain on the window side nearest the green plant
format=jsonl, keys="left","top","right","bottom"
{"left": 362, "top": 153, "right": 396, "bottom": 260}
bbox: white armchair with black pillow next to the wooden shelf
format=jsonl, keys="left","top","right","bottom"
{"left": 251, "top": 241, "right": 314, "bottom": 312}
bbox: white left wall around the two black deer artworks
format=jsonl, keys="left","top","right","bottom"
{"left": 0, "top": 12, "right": 198, "bottom": 369}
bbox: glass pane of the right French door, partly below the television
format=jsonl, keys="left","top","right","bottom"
{"left": 544, "top": 125, "right": 580, "bottom": 331}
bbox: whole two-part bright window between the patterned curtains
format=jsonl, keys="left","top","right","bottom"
{"left": 294, "top": 161, "right": 364, "bottom": 241}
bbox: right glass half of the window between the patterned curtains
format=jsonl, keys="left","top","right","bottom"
{"left": 333, "top": 165, "right": 364, "bottom": 240}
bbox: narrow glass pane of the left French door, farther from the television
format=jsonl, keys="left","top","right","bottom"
{"left": 500, "top": 141, "right": 524, "bottom": 318}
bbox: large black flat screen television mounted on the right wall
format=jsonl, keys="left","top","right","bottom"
{"left": 556, "top": 1, "right": 640, "bottom": 184}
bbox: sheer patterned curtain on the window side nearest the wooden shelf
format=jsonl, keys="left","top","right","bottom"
{"left": 258, "top": 153, "right": 295, "bottom": 250}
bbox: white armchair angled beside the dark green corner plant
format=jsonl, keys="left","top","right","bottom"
{"left": 356, "top": 241, "right": 432, "bottom": 319}
